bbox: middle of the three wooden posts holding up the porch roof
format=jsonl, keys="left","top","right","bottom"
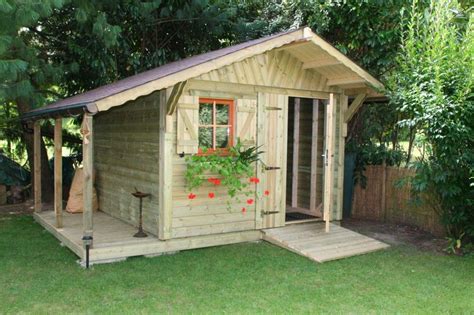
{"left": 54, "top": 118, "right": 63, "bottom": 229}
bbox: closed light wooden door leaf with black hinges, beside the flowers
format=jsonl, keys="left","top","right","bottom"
{"left": 256, "top": 93, "right": 288, "bottom": 229}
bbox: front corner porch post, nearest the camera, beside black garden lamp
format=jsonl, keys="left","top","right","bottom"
{"left": 81, "top": 113, "right": 94, "bottom": 245}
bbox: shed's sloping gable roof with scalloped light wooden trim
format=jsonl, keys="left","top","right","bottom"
{"left": 23, "top": 28, "right": 383, "bottom": 119}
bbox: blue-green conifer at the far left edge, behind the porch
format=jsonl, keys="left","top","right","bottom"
{"left": 0, "top": 0, "right": 68, "bottom": 201}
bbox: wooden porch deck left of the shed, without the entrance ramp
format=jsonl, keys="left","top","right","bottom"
{"left": 34, "top": 211, "right": 261, "bottom": 264}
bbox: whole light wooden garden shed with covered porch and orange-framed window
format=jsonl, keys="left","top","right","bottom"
{"left": 23, "top": 28, "right": 384, "bottom": 263}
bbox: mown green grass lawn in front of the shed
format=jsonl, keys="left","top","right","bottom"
{"left": 0, "top": 215, "right": 474, "bottom": 314}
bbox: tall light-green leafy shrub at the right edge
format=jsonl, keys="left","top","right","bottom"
{"left": 390, "top": 0, "right": 474, "bottom": 240}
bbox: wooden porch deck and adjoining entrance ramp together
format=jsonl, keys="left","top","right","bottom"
{"left": 34, "top": 211, "right": 388, "bottom": 264}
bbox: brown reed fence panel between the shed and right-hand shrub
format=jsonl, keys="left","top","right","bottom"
{"left": 352, "top": 165, "right": 445, "bottom": 236}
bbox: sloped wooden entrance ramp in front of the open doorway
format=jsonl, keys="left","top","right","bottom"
{"left": 262, "top": 222, "right": 388, "bottom": 262}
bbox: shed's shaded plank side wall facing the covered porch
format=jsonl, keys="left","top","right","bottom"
{"left": 94, "top": 93, "right": 159, "bottom": 234}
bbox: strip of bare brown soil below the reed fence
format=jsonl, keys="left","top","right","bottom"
{"left": 341, "top": 219, "right": 447, "bottom": 254}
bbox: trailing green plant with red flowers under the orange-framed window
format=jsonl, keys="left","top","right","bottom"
{"left": 185, "top": 140, "right": 263, "bottom": 199}
